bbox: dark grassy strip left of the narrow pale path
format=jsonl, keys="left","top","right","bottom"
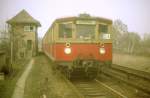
{"left": 0, "top": 60, "right": 29, "bottom": 98}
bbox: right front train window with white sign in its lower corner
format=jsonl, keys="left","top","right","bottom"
{"left": 99, "top": 24, "right": 110, "bottom": 39}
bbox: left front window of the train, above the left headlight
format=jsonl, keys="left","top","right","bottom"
{"left": 59, "top": 23, "right": 72, "bottom": 38}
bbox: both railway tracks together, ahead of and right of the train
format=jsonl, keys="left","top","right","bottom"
{"left": 59, "top": 65, "right": 150, "bottom": 98}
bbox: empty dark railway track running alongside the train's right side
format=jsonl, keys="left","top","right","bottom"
{"left": 98, "top": 64, "right": 150, "bottom": 98}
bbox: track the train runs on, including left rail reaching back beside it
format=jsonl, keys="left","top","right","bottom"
{"left": 59, "top": 70, "right": 129, "bottom": 98}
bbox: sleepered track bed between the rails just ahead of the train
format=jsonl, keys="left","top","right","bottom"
{"left": 72, "top": 80, "right": 128, "bottom": 98}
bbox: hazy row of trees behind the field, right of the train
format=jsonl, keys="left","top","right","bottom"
{"left": 112, "top": 20, "right": 150, "bottom": 56}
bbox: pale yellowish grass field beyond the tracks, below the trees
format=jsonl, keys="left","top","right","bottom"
{"left": 113, "top": 53, "right": 150, "bottom": 72}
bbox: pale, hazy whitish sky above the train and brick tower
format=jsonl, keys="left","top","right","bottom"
{"left": 0, "top": 0, "right": 150, "bottom": 37}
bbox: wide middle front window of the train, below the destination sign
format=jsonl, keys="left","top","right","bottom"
{"left": 76, "top": 24, "right": 96, "bottom": 39}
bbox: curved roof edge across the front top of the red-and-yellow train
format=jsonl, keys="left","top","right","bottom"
{"left": 54, "top": 14, "right": 112, "bottom": 24}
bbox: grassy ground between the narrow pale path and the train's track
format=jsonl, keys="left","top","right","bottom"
{"left": 24, "top": 55, "right": 78, "bottom": 98}
